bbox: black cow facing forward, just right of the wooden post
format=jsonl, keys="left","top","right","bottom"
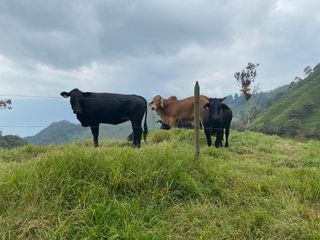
{"left": 203, "top": 97, "right": 232, "bottom": 148}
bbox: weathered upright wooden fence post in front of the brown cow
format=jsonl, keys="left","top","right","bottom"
{"left": 194, "top": 81, "right": 200, "bottom": 159}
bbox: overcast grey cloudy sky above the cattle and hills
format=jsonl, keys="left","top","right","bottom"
{"left": 0, "top": 0, "right": 320, "bottom": 135}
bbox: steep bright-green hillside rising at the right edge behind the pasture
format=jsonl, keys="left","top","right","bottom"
{"left": 252, "top": 69, "right": 320, "bottom": 137}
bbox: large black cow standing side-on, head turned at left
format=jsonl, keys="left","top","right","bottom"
{"left": 60, "top": 88, "right": 148, "bottom": 147}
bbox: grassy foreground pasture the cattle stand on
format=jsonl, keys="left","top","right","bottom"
{"left": 0, "top": 129, "right": 320, "bottom": 239}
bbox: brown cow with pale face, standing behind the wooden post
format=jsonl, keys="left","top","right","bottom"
{"left": 149, "top": 95, "right": 209, "bottom": 128}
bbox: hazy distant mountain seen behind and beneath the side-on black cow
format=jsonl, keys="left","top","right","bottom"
{"left": 24, "top": 109, "right": 159, "bottom": 145}
